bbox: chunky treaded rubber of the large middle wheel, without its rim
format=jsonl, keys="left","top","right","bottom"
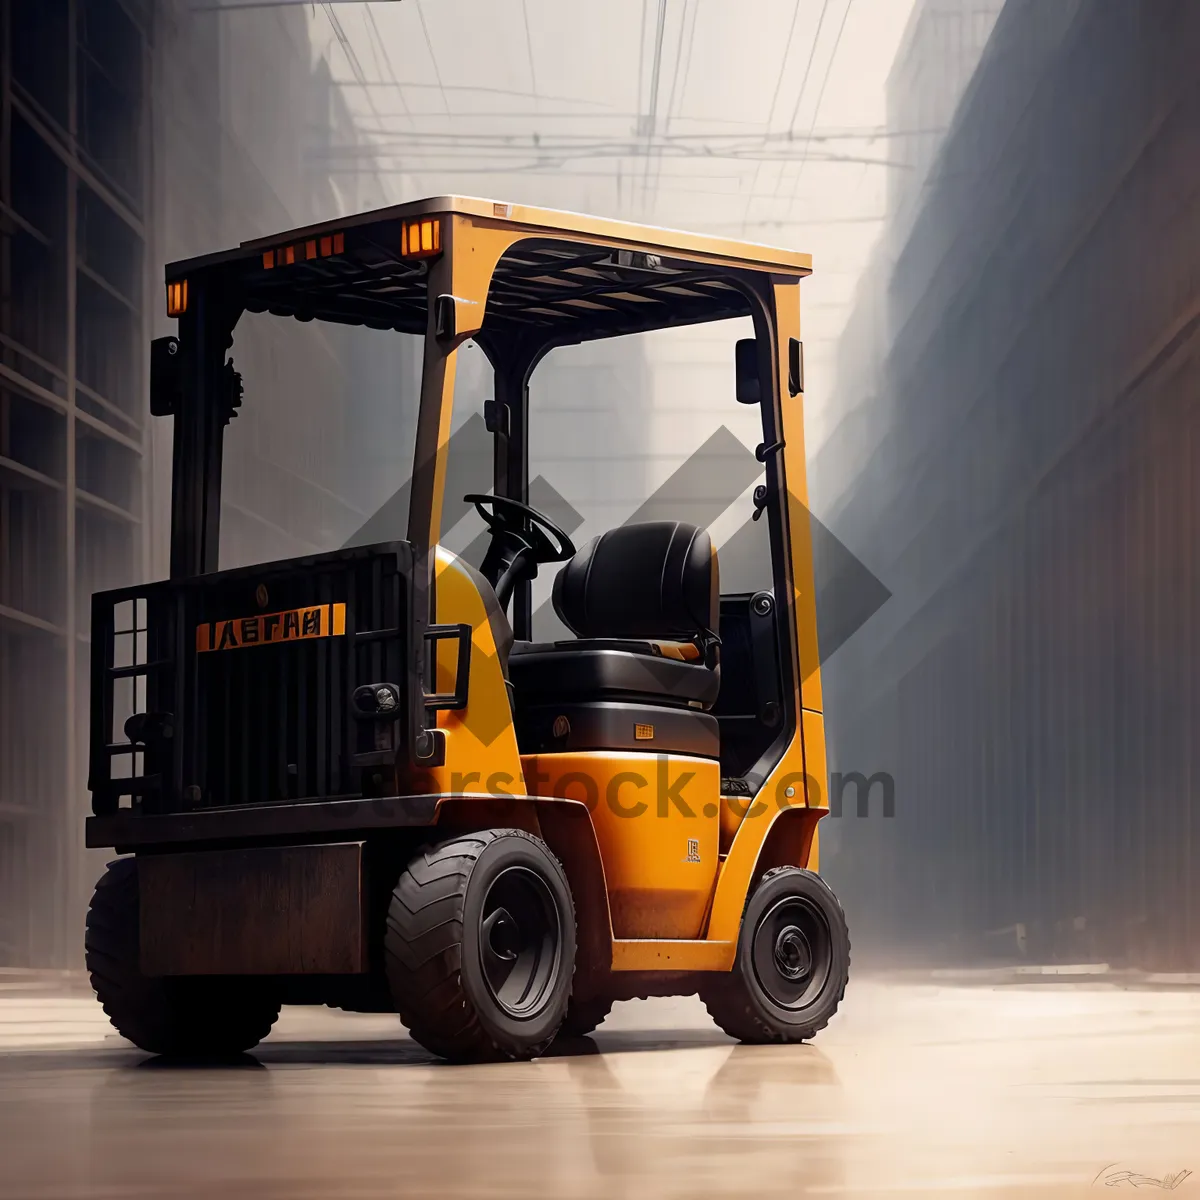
{"left": 384, "top": 829, "right": 575, "bottom": 1062}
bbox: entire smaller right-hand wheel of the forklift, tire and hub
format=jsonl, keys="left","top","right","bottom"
{"left": 700, "top": 866, "right": 850, "bottom": 1043}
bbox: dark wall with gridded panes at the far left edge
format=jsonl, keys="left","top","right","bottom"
{"left": 0, "top": 0, "right": 151, "bottom": 965}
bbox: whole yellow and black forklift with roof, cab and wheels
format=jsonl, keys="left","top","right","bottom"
{"left": 86, "top": 197, "right": 850, "bottom": 1061}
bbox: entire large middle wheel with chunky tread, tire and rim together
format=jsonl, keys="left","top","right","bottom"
{"left": 384, "top": 829, "right": 575, "bottom": 1062}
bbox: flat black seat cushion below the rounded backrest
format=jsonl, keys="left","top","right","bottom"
{"left": 509, "top": 638, "right": 721, "bottom": 709}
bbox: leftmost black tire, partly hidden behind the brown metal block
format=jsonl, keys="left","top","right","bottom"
{"left": 84, "top": 858, "right": 280, "bottom": 1060}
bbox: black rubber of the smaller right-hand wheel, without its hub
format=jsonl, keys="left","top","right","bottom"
{"left": 700, "top": 866, "right": 850, "bottom": 1043}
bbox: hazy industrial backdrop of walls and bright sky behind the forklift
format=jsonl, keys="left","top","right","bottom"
{"left": 0, "top": 0, "right": 1200, "bottom": 968}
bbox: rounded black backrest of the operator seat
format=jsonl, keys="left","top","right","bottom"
{"left": 554, "top": 521, "right": 720, "bottom": 641}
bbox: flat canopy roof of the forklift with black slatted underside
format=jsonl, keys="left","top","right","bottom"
{"left": 167, "top": 197, "right": 811, "bottom": 343}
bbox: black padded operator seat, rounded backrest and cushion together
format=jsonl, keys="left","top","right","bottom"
{"left": 509, "top": 521, "right": 721, "bottom": 715}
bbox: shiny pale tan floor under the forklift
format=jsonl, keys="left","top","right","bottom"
{"left": 0, "top": 978, "right": 1200, "bottom": 1200}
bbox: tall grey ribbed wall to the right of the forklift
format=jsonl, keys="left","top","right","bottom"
{"left": 814, "top": 0, "right": 1200, "bottom": 967}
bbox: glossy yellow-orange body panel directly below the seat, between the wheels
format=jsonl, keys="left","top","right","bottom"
{"left": 523, "top": 751, "right": 721, "bottom": 938}
